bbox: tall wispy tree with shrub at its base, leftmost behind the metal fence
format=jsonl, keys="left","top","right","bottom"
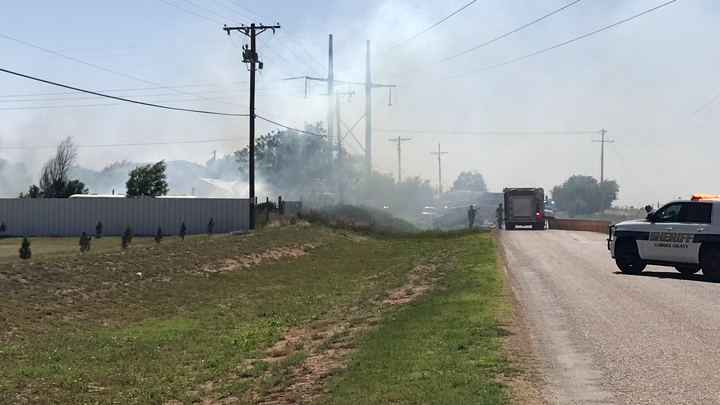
{"left": 20, "top": 137, "right": 88, "bottom": 198}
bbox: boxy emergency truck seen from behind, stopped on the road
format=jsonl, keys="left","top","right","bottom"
{"left": 503, "top": 188, "right": 545, "bottom": 230}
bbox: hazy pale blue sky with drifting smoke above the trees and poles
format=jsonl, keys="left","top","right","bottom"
{"left": 0, "top": 0, "right": 720, "bottom": 206}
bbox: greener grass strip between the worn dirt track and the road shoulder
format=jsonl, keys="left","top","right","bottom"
{"left": 318, "top": 234, "right": 517, "bottom": 405}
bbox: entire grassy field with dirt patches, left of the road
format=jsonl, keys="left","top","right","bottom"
{"left": 0, "top": 219, "right": 516, "bottom": 404}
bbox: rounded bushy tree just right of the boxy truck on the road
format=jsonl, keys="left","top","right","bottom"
{"left": 552, "top": 175, "right": 620, "bottom": 217}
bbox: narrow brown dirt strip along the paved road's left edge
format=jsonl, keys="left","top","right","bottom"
{"left": 492, "top": 230, "right": 549, "bottom": 405}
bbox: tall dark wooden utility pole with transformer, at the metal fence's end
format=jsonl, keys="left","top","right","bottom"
{"left": 223, "top": 24, "right": 280, "bottom": 229}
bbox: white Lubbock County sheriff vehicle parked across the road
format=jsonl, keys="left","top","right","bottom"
{"left": 608, "top": 194, "right": 720, "bottom": 281}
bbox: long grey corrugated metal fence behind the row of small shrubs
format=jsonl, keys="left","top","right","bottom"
{"left": 0, "top": 198, "right": 250, "bottom": 236}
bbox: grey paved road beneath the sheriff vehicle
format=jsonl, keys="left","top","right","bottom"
{"left": 500, "top": 230, "right": 720, "bottom": 404}
